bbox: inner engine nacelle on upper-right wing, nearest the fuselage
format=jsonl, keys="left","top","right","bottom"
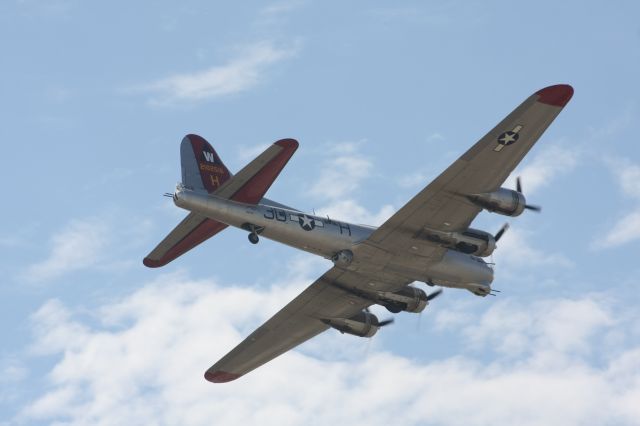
{"left": 422, "top": 228, "right": 496, "bottom": 257}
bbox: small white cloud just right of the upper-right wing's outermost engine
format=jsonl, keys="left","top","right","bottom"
{"left": 504, "top": 145, "right": 579, "bottom": 195}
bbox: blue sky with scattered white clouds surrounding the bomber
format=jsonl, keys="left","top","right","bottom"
{"left": 0, "top": 0, "right": 640, "bottom": 425}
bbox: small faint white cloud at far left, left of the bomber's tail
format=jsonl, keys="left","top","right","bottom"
{"left": 25, "top": 219, "right": 109, "bottom": 281}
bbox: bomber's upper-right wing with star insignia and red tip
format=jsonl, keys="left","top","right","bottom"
{"left": 366, "top": 84, "right": 573, "bottom": 254}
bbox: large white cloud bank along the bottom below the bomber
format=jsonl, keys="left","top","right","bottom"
{"left": 14, "top": 275, "right": 640, "bottom": 425}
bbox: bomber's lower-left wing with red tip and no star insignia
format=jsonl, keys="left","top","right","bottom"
{"left": 204, "top": 267, "right": 408, "bottom": 383}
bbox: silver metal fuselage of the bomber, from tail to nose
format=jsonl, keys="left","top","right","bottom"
{"left": 173, "top": 186, "right": 493, "bottom": 295}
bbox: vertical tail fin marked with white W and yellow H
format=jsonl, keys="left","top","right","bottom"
{"left": 180, "top": 135, "right": 231, "bottom": 194}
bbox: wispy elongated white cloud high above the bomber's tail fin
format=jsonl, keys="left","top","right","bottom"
{"left": 134, "top": 41, "right": 298, "bottom": 105}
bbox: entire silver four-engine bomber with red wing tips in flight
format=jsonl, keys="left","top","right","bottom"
{"left": 144, "top": 84, "right": 573, "bottom": 383}
